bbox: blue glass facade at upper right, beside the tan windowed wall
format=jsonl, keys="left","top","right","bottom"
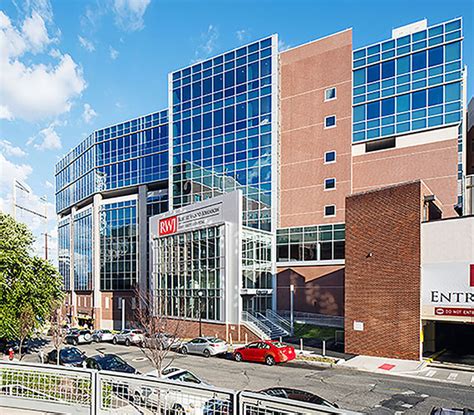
{"left": 352, "top": 19, "right": 463, "bottom": 143}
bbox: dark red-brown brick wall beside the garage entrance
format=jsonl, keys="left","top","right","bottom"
{"left": 345, "top": 181, "right": 423, "bottom": 360}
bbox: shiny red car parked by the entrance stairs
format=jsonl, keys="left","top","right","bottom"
{"left": 234, "top": 340, "right": 296, "bottom": 366}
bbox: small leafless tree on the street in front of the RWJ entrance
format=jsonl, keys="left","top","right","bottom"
{"left": 135, "top": 290, "right": 185, "bottom": 377}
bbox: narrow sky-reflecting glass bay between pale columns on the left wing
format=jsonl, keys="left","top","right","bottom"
{"left": 73, "top": 209, "right": 93, "bottom": 291}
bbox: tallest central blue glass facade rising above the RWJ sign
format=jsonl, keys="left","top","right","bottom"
{"left": 169, "top": 36, "right": 278, "bottom": 231}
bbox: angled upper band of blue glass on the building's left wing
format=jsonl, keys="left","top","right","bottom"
{"left": 56, "top": 110, "right": 169, "bottom": 213}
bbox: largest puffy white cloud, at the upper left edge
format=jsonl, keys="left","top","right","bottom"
{"left": 0, "top": 11, "right": 86, "bottom": 121}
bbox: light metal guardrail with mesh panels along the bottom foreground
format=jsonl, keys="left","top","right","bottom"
{"left": 0, "top": 362, "right": 357, "bottom": 415}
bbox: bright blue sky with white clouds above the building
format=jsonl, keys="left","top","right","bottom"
{"left": 0, "top": 0, "right": 474, "bottom": 255}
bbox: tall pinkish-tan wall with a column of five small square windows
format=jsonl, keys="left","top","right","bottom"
{"left": 279, "top": 30, "right": 352, "bottom": 227}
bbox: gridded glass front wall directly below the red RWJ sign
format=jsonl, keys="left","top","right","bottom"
{"left": 153, "top": 226, "right": 224, "bottom": 321}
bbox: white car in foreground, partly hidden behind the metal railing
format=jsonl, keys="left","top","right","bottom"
{"left": 133, "top": 367, "right": 210, "bottom": 415}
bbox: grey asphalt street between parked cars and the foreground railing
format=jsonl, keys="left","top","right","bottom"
{"left": 20, "top": 343, "right": 474, "bottom": 414}
